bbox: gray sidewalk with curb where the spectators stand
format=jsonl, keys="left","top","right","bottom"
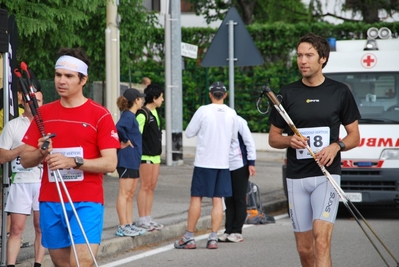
{"left": 13, "top": 148, "right": 286, "bottom": 267}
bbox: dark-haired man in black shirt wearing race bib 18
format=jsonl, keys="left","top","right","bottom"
{"left": 269, "top": 33, "right": 360, "bottom": 267}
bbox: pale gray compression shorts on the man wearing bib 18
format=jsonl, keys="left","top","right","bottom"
{"left": 287, "top": 175, "right": 341, "bottom": 232}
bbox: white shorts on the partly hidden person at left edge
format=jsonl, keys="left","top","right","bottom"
{"left": 4, "top": 183, "right": 40, "bottom": 215}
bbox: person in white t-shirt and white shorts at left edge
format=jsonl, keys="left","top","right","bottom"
{"left": 0, "top": 92, "right": 45, "bottom": 267}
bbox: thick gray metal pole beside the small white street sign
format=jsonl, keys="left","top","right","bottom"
{"left": 167, "top": 0, "right": 183, "bottom": 166}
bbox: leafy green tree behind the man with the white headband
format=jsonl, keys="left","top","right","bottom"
{"left": 0, "top": 0, "right": 160, "bottom": 81}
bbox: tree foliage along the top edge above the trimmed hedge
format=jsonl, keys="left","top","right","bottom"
{"left": 186, "top": 0, "right": 399, "bottom": 25}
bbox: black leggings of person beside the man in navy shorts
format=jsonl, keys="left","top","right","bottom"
{"left": 224, "top": 166, "right": 249, "bottom": 234}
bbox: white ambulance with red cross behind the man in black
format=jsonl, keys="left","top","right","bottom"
{"left": 323, "top": 28, "right": 399, "bottom": 206}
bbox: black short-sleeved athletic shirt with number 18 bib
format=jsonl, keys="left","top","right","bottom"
{"left": 269, "top": 77, "right": 360, "bottom": 179}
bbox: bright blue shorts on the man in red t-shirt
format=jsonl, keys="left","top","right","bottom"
{"left": 40, "top": 202, "right": 104, "bottom": 249}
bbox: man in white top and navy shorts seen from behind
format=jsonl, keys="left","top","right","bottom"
{"left": 174, "top": 82, "right": 238, "bottom": 249}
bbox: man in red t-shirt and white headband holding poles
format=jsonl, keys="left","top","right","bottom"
{"left": 21, "top": 48, "right": 120, "bottom": 266}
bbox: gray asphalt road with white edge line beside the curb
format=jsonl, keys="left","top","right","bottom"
{"left": 99, "top": 208, "right": 399, "bottom": 267}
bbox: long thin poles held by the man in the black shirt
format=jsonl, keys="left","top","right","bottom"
{"left": 258, "top": 85, "right": 399, "bottom": 267}
